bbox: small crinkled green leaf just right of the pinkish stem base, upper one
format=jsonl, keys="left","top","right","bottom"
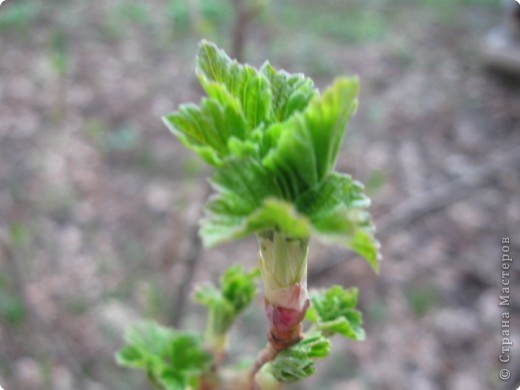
{"left": 306, "top": 285, "right": 365, "bottom": 340}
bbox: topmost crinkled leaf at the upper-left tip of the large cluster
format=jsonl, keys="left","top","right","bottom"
{"left": 196, "top": 41, "right": 274, "bottom": 130}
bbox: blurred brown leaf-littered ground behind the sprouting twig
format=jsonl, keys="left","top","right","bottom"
{"left": 0, "top": 0, "right": 520, "bottom": 390}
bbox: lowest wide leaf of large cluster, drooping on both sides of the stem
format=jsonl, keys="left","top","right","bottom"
{"left": 201, "top": 163, "right": 380, "bottom": 272}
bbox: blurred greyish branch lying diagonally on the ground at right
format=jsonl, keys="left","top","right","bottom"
{"left": 309, "top": 147, "right": 520, "bottom": 278}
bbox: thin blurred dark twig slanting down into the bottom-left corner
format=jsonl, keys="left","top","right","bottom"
{"left": 0, "top": 232, "right": 85, "bottom": 390}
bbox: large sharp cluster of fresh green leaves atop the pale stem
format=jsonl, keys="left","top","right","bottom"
{"left": 163, "top": 41, "right": 379, "bottom": 270}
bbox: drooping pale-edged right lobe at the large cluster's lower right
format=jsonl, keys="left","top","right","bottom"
{"left": 295, "top": 173, "right": 380, "bottom": 272}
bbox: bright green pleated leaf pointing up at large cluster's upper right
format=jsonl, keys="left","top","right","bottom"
{"left": 263, "top": 78, "right": 359, "bottom": 200}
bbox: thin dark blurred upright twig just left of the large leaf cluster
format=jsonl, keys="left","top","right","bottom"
{"left": 172, "top": 182, "right": 211, "bottom": 327}
